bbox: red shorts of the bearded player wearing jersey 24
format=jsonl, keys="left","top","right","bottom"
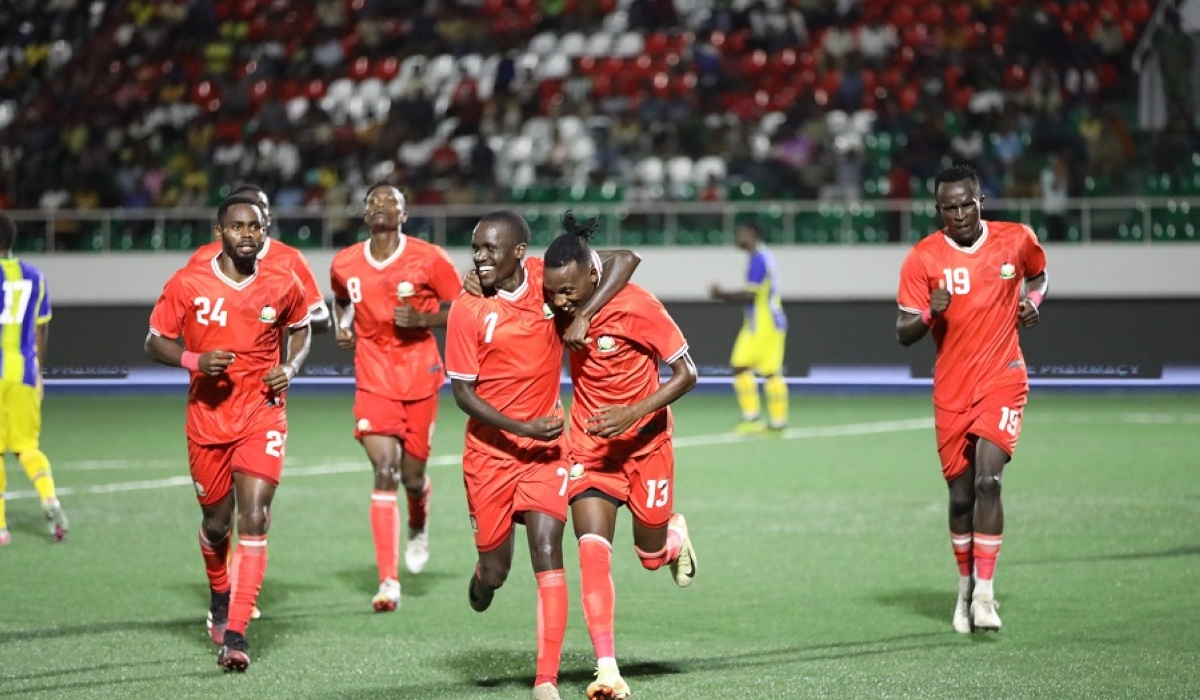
{"left": 187, "top": 421, "right": 288, "bottom": 505}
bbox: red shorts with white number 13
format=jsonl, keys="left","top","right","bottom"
{"left": 568, "top": 439, "right": 674, "bottom": 527}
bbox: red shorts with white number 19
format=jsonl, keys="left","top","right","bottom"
{"left": 934, "top": 384, "right": 1030, "bottom": 481}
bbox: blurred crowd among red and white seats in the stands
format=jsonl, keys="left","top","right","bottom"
{"left": 0, "top": 0, "right": 1196, "bottom": 247}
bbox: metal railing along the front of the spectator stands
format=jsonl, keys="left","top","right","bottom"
{"left": 10, "top": 197, "right": 1200, "bottom": 253}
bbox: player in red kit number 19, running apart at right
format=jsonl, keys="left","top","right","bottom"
{"left": 896, "top": 166, "right": 1046, "bottom": 634}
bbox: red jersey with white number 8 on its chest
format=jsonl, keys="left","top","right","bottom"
{"left": 330, "top": 234, "right": 462, "bottom": 401}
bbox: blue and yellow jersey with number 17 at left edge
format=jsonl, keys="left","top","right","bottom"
{"left": 0, "top": 258, "right": 50, "bottom": 387}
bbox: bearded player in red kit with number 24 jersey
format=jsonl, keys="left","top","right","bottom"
{"left": 145, "top": 197, "right": 310, "bottom": 671}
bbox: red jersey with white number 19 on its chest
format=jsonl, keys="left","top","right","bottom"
{"left": 896, "top": 221, "right": 1046, "bottom": 411}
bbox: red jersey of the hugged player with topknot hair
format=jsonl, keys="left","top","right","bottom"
{"left": 569, "top": 283, "right": 688, "bottom": 465}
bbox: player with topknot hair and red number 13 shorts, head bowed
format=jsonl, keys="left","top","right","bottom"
{"left": 544, "top": 213, "right": 696, "bottom": 700}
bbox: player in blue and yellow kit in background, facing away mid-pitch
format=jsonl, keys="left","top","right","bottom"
{"left": 708, "top": 222, "right": 787, "bottom": 433}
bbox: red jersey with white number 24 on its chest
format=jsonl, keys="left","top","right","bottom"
{"left": 150, "top": 255, "right": 308, "bottom": 444}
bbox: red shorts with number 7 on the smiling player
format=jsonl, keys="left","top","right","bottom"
{"left": 462, "top": 445, "right": 568, "bottom": 552}
